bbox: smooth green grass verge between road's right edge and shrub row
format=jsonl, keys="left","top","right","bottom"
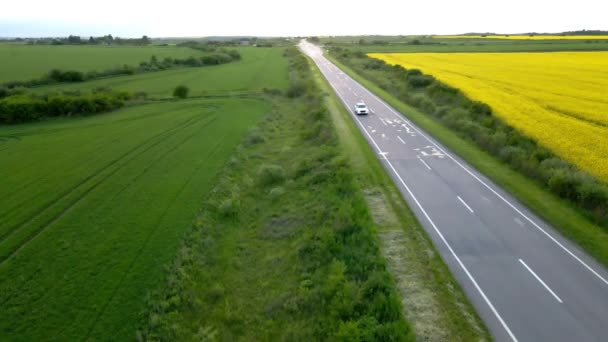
{"left": 327, "top": 56, "right": 608, "bottom": 265}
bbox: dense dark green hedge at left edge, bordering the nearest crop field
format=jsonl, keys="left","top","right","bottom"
{"left": 0, "top": 90, "right": 133, "bottom": 124}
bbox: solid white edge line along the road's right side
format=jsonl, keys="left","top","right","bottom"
{"left": 349, "top": 62, "right": 608, "bottom": 285}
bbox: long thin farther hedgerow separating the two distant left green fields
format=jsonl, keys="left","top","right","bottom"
{"left": 0, "top": 49, "right": 241, "bottom": 91}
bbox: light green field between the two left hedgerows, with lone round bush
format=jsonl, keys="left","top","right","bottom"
{"left": 34, "top": 48, "right": 287, "bottom": 97}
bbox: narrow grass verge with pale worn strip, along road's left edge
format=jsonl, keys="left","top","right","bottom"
{"left": 311, "top": 50, "right": 490, "bottom": 341}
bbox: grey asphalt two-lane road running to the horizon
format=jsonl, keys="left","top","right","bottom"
{"left": 300, "top": 42, "right": 608, "bottom": 341}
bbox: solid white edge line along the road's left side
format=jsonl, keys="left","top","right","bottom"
{"left": 325, "top": 70, "right": 517, "bottom": 342}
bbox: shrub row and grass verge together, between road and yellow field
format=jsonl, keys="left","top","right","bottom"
{"left": 330, "top": 47, "right": 608, "bottom": 264}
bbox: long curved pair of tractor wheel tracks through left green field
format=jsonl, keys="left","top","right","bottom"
{"left": 0, "top": 111, "right": 215, "bottom": 265}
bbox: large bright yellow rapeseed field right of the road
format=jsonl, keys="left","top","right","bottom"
{"left": 369, "top": 52, "right": 608, "bottom": 181}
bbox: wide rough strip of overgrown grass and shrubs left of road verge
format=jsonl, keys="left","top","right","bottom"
{"left": 139, "top": 48, "right": 413, "bottom": 341}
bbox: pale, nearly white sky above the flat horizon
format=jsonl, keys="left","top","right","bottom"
{"left": 0, "top": 0, "right": 608, "bottom": 37}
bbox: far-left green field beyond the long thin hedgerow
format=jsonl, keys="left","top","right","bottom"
{"left": 0, "top": 44, "right": 203, "bottom": 83}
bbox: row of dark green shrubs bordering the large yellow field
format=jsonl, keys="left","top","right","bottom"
{"left": 330, "top": 48, "right": 608, "bottom": 232}
